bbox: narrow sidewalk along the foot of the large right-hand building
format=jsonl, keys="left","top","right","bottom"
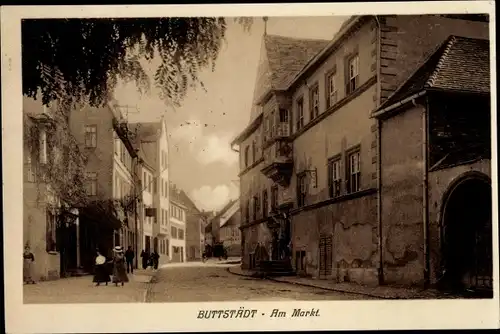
{"left": 228, "top": 266, "right": 459, "bottom": 299}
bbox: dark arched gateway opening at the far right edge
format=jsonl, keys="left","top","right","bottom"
{"left": 441, "top": 172, "right": 493, "bottom": 291}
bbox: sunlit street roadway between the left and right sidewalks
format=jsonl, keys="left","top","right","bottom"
{"left": 148, "top": 261, "right": 375, "bottom": 303}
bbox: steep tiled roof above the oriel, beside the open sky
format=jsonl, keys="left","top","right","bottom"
{"left": 264, "top": 35, "right": 329, "bottom": 89}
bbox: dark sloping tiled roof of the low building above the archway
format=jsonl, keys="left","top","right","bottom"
{"left": 378, "top": 36, "right": 490, "bottom": 110}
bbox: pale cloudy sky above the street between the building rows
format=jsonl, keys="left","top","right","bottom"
{"left": 115, "top": 16, "right": 346, "bottom": 210}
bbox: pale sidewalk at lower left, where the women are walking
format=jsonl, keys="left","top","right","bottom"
{"left": 23, "top": 270, "right": 155, "bottom": 304}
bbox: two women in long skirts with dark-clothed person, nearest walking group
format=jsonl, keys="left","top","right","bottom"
{"left": 93, "top": 246, "right": 134, "bottom": 286}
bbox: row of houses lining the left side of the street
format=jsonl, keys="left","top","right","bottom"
{"left": 23, "top": 97, "right": 204, "bottom": 280}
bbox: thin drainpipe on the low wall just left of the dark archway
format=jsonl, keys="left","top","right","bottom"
{"left": 420, "top": 99, "right": 430, "bottom": 288}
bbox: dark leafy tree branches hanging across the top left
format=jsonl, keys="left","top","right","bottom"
{"left": 22, "top": 17, "right": 252, "bottom": 106}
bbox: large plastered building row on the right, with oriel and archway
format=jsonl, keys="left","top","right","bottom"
{"left": 231, "top": 15, "right": 492, "bottom": 290}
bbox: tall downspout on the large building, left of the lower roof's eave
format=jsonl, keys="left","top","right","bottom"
{"left": 375, "top": 15, "right": 384, "bottom": 285}
